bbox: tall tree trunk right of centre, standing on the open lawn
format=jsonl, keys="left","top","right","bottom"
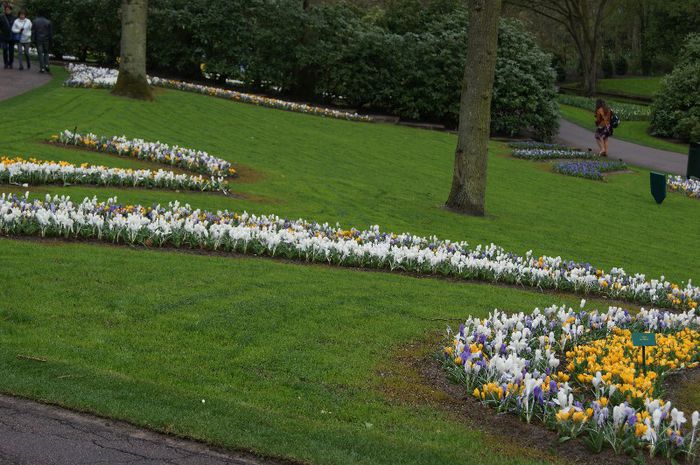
{"left": 446, "top": 0, "right": 502, "bottom": 216}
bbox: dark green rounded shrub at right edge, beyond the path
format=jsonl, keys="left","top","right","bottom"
{"left": 651, "top": 34, "right": 700, "bottom": 142}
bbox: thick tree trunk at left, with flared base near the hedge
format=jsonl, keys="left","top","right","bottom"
{"left": 112, "top": 0, "right": 153, "bottom": 100}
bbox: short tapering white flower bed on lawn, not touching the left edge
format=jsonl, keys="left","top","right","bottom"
{"left": 49, "top": 129, "right": 236, "bottom": 176}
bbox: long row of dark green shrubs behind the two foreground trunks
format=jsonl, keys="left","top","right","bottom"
{"left": 27, "top": 0, "right": 557, "bottom": 138}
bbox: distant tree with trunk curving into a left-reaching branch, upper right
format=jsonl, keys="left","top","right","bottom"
{"left": 510, "top": 0, "right": 615, "bottom": 95}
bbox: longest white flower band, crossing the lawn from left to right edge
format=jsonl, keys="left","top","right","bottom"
{"left": 0, "top": 194, "right": 700, "bottom": 308}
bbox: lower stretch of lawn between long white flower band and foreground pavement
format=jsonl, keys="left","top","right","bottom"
{"left": 0, "top": 239, "right": 592, "bottom": 465}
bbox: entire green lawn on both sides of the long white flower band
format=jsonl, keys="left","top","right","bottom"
{"left": 0, "top": 73, "right": 700, "bottom": 464}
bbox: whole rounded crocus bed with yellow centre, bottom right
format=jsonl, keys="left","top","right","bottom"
{"left": 443, "top": 301, "right": 700, "bottom": 458}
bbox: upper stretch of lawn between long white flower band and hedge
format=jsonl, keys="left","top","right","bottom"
{"left": 0, "top": 69, "right": 700, "bottom": 280}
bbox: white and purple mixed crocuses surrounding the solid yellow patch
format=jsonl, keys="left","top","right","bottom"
{"left": 444, "top": 301, "right": 700, "bottom": 456}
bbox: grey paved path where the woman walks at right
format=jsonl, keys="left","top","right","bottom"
{"left": 557, "top": 119, "right": 688, "bottom": 175}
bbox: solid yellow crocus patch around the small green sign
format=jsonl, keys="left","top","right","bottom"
{"left": 566, "top": 328, "right": 700, "bottom": 400}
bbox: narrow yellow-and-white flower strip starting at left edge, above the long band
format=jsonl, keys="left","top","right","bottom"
{"left": 0, "top": 157, "right": 228, "bottom": 192}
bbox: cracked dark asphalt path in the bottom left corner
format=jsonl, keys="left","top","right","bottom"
{"left": 0, "top": 395, "right": 285, "bottom": 465}
